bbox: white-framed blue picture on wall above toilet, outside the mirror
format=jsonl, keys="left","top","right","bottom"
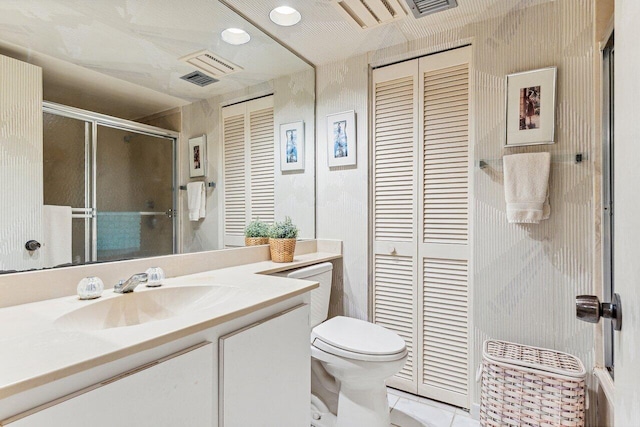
{"left": 327, "top": 110, "right": 358, "bottom": 168}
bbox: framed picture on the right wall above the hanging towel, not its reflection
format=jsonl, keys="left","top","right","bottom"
{"left": 505, "top": 67, "right": 557, "bottom": 147}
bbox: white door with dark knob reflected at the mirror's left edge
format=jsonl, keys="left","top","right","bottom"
{"left": 0, "top": 55, "right": 46, "bottom": 271}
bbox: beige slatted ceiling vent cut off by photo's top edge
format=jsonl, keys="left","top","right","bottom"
{"left": 332, "top": 0, "right": 407, "bottom": 29}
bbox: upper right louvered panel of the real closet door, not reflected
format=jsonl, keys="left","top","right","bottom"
{"left": 423, "top": 64, "right": 469, "bottom": 245}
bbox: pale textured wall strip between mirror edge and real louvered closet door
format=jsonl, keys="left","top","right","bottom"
{"left": 316, "top": 55, "right": 369, "bottom": 319}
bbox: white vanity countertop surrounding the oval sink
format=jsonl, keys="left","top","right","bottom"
{"left": 0, "top": 252, "right": 341, "bottom": 399}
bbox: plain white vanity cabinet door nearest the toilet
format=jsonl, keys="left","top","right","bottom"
{"left": 219, "top": 304, "right": 311, "bottom": 427}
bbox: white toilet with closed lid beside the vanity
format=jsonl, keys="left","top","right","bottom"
{"left": 278, "top": 262, "right": 407, "bottom": 427}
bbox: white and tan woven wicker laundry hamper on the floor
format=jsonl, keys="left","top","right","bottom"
{"left": 480, "top": 340, "right": 586, "bottom": 427}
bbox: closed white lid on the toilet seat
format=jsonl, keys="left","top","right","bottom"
{"left": 311, "top": 316, "right": 406, "bottom": 355}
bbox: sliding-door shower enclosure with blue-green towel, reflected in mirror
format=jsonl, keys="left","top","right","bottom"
{"left": 43, "top": 102, "right": 177, "bottom": 264}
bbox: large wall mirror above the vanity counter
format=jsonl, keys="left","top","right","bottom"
{"left": 0, "top": 0, "right": 316, "bottom": 273}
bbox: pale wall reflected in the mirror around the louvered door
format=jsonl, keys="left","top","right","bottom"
{"left": 178, "top": 69, "right": 315, "bottom": 253}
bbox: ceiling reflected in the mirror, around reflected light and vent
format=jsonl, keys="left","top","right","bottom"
{"left": 0, "top": 0, "right": 309, "bottom": 117}
